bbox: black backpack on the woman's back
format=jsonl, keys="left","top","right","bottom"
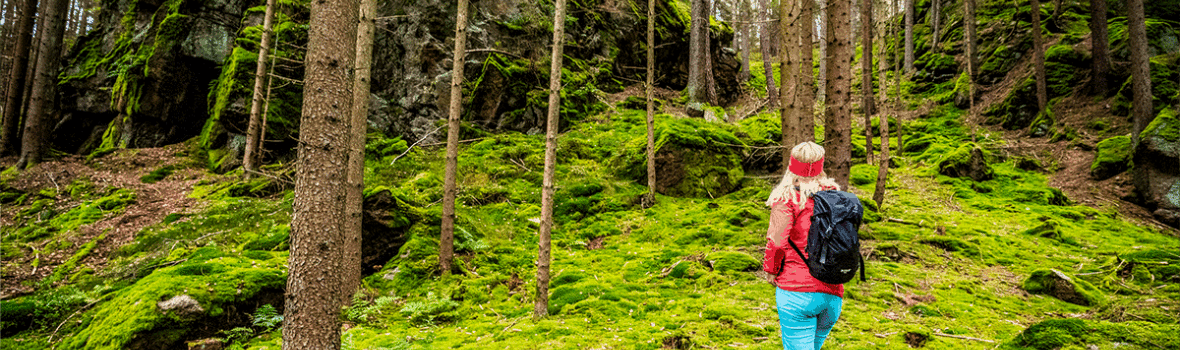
{"left": 787, "top": 190, "right": 865, "bottom": 284}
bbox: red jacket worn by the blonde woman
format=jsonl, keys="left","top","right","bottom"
{"left": 763, "top": 194, "right": 844, "bottom": 298}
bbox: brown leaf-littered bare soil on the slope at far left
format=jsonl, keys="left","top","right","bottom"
{"left": 0, "top": 144, "right": 202, "bottom": 299}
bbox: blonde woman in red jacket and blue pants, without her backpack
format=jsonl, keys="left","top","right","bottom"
{"left": 763, "top": 141, "right": 844, "bottom": 350}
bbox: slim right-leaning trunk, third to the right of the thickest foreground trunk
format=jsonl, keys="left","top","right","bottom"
{"left": 532, "top": 0, "right": 565, "bottom": 319}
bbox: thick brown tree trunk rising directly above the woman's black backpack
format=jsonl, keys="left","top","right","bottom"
{"left": 824, "top": 0, "right": 856, "bottom": 189}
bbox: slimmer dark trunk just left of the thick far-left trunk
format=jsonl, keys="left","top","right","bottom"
{"left": 0, "top": 0, "right": 37, "bottom": 156}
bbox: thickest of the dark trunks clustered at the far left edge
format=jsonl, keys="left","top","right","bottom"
{"left": 18, "top": 0, "right": 70, "bottom": 169}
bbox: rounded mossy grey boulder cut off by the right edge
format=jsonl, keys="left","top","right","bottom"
{"left": 1134, "top": 108, "right": 1180, "bottom": 227}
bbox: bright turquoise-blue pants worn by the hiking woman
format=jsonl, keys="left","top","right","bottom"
{"left": 774, "top": 288, "right": 844, "bottom": 350}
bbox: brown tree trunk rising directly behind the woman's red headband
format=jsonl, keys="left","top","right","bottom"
{"left": 776, "top": 0, "right": 801, "bottom": 167}
